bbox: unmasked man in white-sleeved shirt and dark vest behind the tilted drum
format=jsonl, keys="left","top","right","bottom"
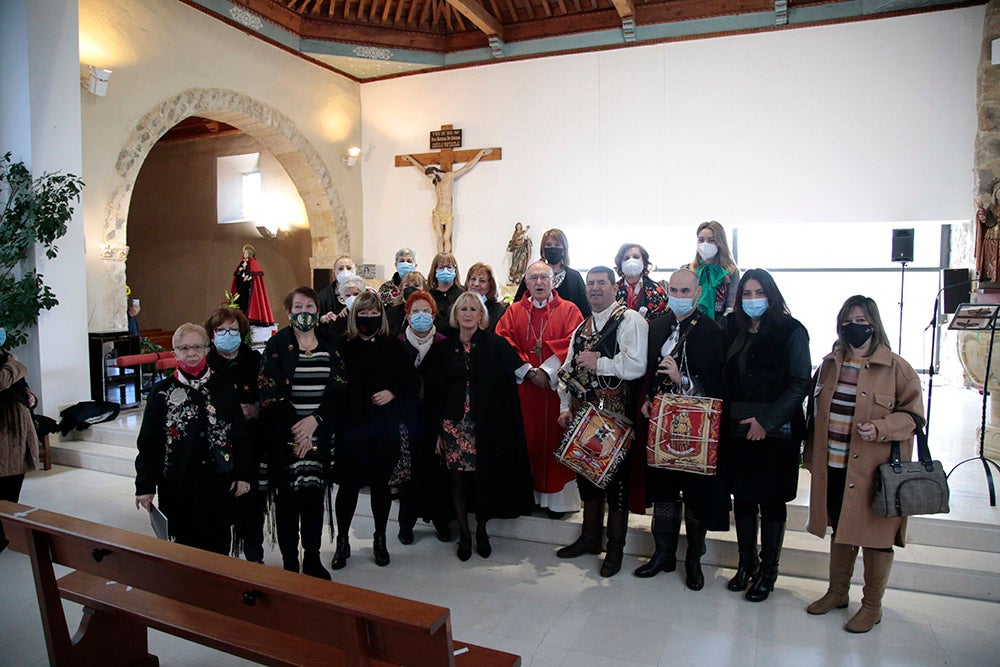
{"left": 556, "top": 266, "right": 648, "bottom": 577}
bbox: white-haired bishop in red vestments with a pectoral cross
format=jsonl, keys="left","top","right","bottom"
{"left": 496, "top": 262, "right": 583, "bottom": 513}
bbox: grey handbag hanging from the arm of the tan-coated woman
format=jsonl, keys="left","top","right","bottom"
{"left": 872, "top": 413, "right": 950, "bottom": 517}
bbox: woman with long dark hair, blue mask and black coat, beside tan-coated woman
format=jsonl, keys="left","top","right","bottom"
{"left": 725, "top": 269, "right": 812, "bottom": 602}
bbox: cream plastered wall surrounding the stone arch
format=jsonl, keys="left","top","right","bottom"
{"left": 79, "top": 0, "right": 363, "bottom": 330}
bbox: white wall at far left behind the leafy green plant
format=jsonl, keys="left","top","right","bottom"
{"left": 0, "top": 0, "right": 90, "bottom": 416}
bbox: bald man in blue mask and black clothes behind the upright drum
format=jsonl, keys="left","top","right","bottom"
{"left": 633, "top": 269, "right": 729, "bottom": 591}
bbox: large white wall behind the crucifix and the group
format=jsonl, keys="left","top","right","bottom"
{"left": 355, "top": 6, "right": 984, "bottom": 276}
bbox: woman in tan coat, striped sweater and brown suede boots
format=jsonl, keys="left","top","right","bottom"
{"left": 803, "top": 295, "right": 924, "bottom": 632}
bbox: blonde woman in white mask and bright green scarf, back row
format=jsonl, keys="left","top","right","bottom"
{"left": 688, "top": 220, "right": 740, "bottom": 321}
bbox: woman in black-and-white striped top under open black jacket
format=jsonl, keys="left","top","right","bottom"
{"left": 259, "top": 287, "right": 344, "bottom": 579}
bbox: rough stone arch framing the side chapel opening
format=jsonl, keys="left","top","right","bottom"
{"left": 100, "top": 88, "right": 351, "bottom": 331}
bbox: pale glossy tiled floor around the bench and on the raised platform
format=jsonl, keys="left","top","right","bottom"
{"left": 0, "top": 388, "right": 1000, "bottom": 667}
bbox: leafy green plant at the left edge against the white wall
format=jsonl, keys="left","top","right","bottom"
{"left": 0, "top": 153, "right": 83, "bottom": 348}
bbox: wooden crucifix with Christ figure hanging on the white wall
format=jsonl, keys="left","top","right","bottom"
{"left": 396, "top": 125, "right": 503, "bottom": 253}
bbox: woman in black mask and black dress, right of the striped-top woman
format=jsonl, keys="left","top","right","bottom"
{"left": 332, "top": 292, "right": 419, "bottom": 570}
